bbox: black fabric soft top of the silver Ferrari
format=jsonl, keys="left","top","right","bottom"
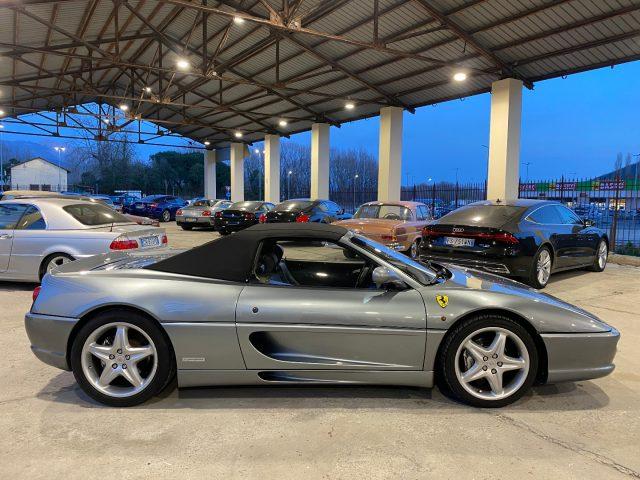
{"left": 145, "top": 223, "right": 347, "bottom": 282}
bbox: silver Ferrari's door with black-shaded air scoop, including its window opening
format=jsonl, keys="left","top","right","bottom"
{"left": 236, "top": 241, "right": 426, "bottom": 371}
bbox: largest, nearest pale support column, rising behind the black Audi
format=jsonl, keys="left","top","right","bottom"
{"left": 487, "top": 78, "right": 522, "bottom": 200}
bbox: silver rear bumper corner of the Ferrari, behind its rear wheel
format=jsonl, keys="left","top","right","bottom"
{"left": 24, "top": 313, "right": 78, "bottom": 370}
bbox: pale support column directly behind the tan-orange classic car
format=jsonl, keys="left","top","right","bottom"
{"left": 378, "top": 107, "right": 403, "bottom": 202}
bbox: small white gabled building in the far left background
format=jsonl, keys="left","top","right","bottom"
{"left": 11, "top": 157, "right": 69, "bottom": 192}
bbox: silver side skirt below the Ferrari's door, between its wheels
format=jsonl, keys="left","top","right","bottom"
{"left": 178, "top": 370, "right": 433, "bottom": 388}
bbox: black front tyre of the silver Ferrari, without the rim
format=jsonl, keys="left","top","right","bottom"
{"left": 437, "top": 314, "right": 538, "bottom": 408}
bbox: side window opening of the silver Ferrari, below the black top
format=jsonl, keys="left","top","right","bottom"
{"left": 255, "top": 240, "right": 375, "bottom": 289}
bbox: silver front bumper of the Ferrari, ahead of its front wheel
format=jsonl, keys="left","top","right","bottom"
{"left": 541, "top": 328, "right": 620, "bottom": 383}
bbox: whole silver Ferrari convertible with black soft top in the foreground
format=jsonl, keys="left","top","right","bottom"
{"left": 26, "top": 224, "right": 619, "bottom": 407}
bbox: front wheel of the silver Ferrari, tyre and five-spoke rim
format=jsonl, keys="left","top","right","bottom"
{"left": 438, "top": 315, "right": 538, "bottom": 408}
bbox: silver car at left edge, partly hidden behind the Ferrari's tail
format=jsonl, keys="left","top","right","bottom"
{"left": 0, "top": 197, "right": 167, "bottom": 282}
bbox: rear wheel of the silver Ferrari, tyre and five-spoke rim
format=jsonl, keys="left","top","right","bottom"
{"left": 70, "top": 310, "right": 175, "bottom": 407}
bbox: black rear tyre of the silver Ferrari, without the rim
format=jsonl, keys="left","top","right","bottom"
{"left": 70, "top": 309, "right": 176, "bottom": 407}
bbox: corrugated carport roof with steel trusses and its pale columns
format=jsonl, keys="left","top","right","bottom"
{"left": 0, "top": 0, "right": 640, "bottom": 201}
